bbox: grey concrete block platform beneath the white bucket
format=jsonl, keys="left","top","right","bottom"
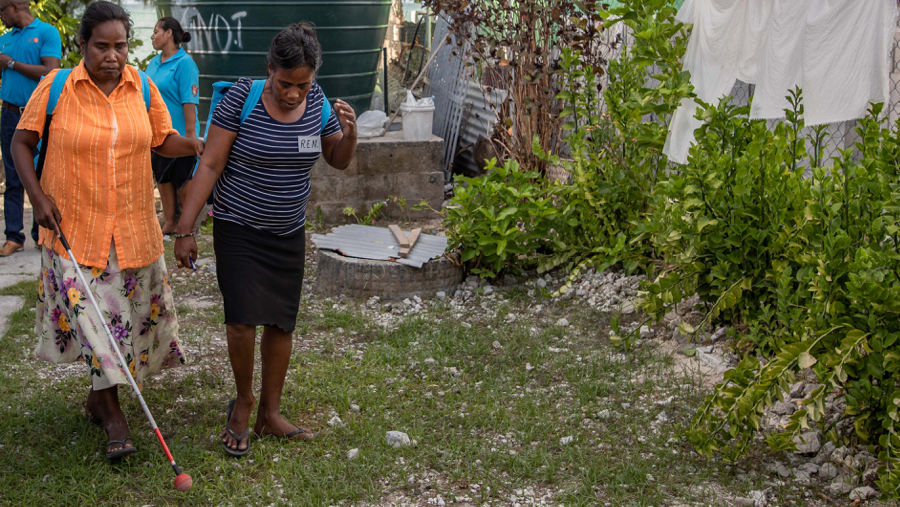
{"left": 306, "top": 132, "right": 444, "bottom": 223}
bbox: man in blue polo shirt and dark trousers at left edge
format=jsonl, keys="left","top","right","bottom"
{"left": 0, "top": 0, "right": 62, "bottom": 257}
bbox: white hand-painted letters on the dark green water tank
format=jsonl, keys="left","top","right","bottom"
{"left": 172, "top": 5, "right": 247, "bottom": 54}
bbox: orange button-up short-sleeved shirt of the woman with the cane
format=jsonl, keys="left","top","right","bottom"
{"left": 18, "top": 63, "right": 177, "bottom": 269}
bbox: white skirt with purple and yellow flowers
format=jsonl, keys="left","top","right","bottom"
{"left": 34, "top": 246, "right": 184, "bottom": 390}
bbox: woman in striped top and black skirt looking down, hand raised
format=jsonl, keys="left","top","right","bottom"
{"left": 175, "top": 24, "right": 356, "bottom": 456}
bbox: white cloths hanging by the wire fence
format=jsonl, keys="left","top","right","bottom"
{"left": 663, "top": 0, "right": 897, "bottom": 164}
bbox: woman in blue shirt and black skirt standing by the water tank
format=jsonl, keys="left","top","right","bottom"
{"left": 147, "top": 17, "right": 200, "bottom": 235}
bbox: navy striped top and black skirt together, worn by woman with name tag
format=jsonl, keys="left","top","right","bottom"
{"left": 212, "top": 79, "right": 341, "bottom": 332}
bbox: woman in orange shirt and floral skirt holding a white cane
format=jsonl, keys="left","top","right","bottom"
{"left": 11, "top": 1, "right": 203, "bottom": 459}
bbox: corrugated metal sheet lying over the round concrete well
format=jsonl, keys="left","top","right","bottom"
{"left": 312, "top": 225, "right": 447, "bottom": 268}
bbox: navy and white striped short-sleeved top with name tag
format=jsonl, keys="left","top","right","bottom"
{"left": 212, "top": 78, "right": 341, "bottom": 236}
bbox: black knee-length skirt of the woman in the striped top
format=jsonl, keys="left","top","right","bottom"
{"left": 213, "top": 219, "right": 306, "bottom": 332}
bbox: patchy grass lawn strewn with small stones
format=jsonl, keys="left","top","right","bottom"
{"left": 0, "top": 238, "right": 780, "bottom": 506}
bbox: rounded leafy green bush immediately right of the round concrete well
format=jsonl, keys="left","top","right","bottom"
{"left": 444, "top": 159, "right": 556, "bottom": 278}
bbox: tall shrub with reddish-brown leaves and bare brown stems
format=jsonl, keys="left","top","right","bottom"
{"left": 422, "top": 0, "right": 614, "bottom": 173}
